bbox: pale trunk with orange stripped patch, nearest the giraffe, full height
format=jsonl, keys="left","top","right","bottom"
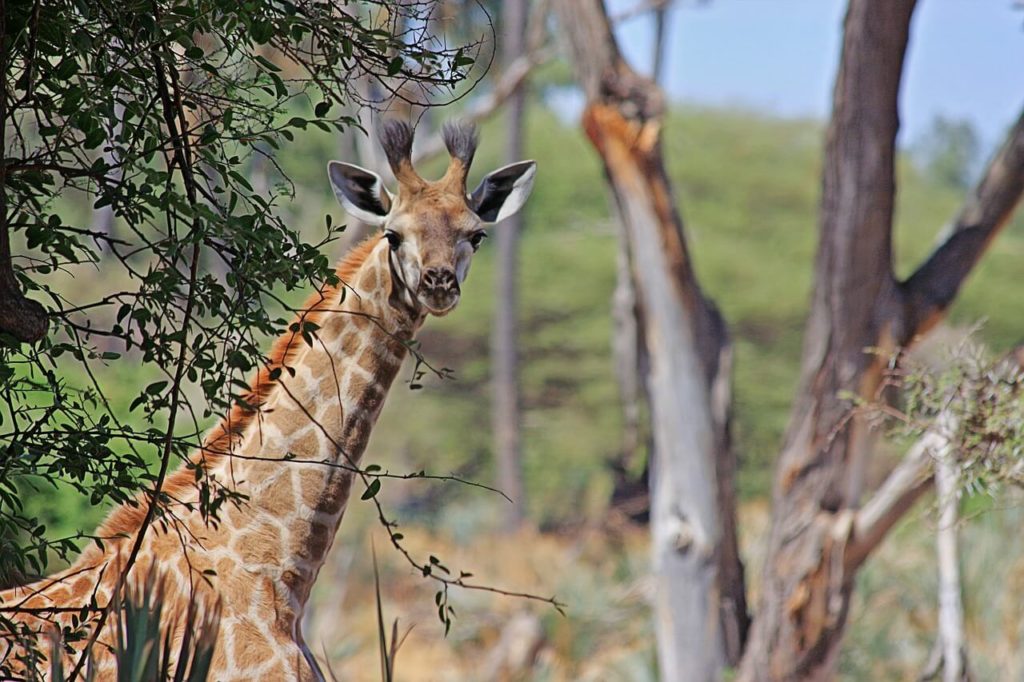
{"left": 557, "top": 0, "right": 746, "bottom": 680}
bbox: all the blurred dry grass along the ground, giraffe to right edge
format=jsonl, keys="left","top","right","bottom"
{"left": 307, "top": 493, "right": 1024, "bottom": 682}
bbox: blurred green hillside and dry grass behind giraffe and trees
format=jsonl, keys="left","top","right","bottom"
{"left": 25, "top": 94, "right": 1024, "bottom": 680}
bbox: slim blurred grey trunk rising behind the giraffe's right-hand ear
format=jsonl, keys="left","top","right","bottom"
{"left": 490, "top": 0, "right": 527, "bottom": 530}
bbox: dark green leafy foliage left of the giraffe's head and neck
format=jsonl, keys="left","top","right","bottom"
{"left": 0, "top": 0, "right": 480, "bottom": 659}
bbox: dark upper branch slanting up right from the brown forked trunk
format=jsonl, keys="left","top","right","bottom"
{"left": 901, "top": 107, "right": 1024, "bottom": 343}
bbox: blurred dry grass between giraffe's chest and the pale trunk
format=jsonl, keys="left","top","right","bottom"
{"left": 309, "top": 512, "right": 653, "bottom": 681}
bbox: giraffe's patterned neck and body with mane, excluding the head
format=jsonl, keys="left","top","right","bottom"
{"left": 0, "top": 238, "right": 423, "bottom": 679}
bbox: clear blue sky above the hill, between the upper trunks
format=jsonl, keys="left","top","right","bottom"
{"left": 607, "top": 0, "right": 1024, "bottom": 150}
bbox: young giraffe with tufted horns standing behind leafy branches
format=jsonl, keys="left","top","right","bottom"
{"left": 0, "top": 121, "right": 536, "bottom": 680}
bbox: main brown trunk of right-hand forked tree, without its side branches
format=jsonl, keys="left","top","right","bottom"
{"left": 742, "top": 0, "right": 914, "bottom": 680}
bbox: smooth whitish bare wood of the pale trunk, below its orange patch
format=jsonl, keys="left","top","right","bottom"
{"left": 621, "top": 180, "right": 724, "bottom": 682}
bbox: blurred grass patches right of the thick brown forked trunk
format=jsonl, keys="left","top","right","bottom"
{"left": 841, "top": 495, "right": 1024, "bottom": 680}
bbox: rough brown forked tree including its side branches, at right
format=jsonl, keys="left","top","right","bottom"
{"left": 739, "top": 0, "right": 1024, "bottom": 680}
